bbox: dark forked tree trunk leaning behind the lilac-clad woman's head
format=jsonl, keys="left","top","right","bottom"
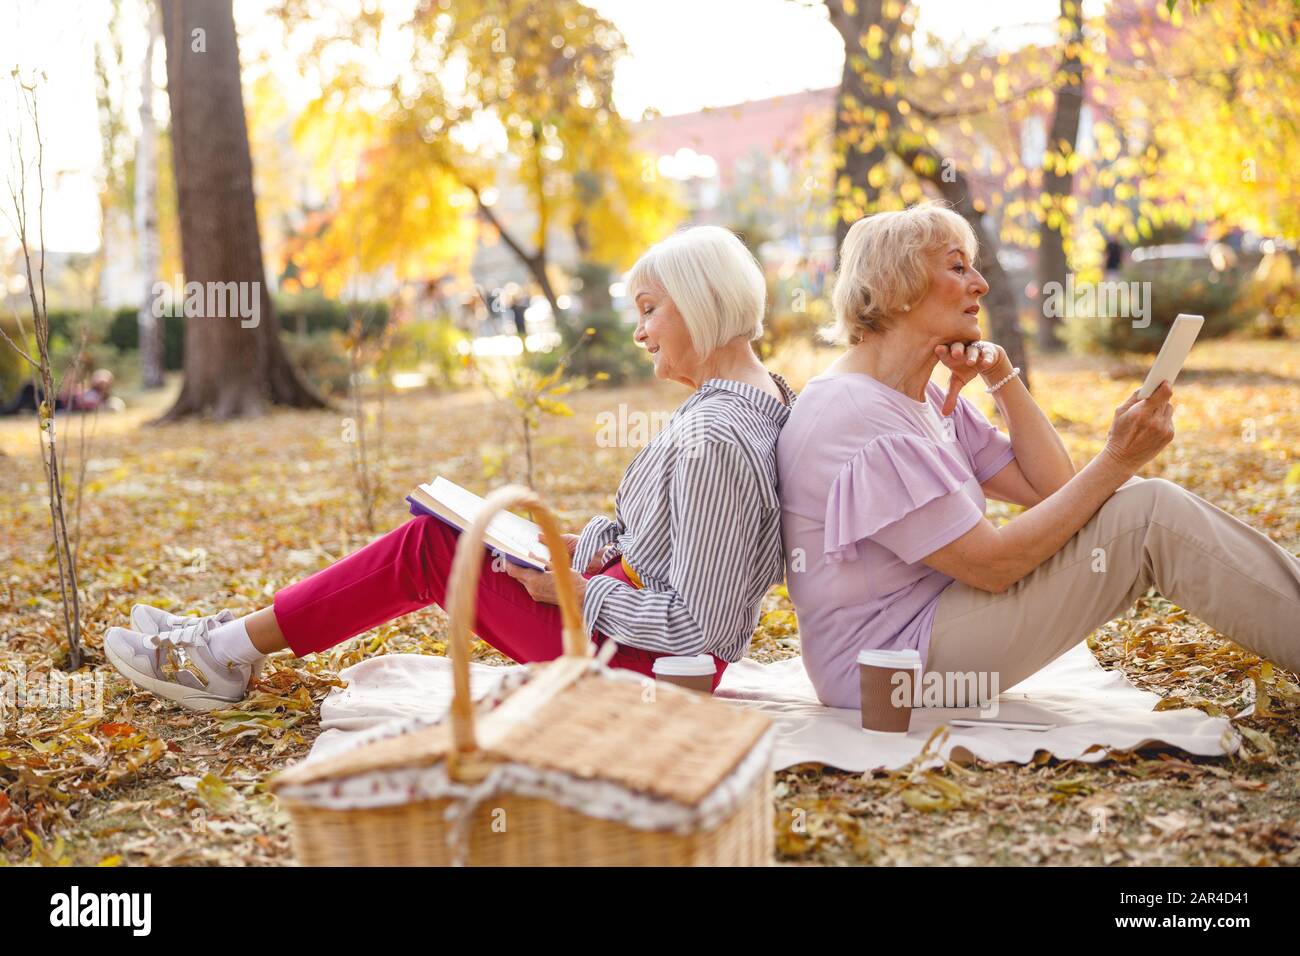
{"left": 826, "top": 0, "right": 1030, "bottom": 388}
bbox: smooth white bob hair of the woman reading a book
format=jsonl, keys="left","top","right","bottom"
{"left": 628, "top": 226, "right": 767, "bottom": 356}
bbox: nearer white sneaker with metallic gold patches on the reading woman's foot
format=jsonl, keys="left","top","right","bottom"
{"left": 104, "top": 618, "right": 252, "bottom": 710}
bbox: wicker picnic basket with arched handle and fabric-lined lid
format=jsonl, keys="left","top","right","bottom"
{"left": 268, "top": 485, "right": 774, "bottom": 866}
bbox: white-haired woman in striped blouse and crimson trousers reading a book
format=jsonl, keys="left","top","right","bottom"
{"left": 104, "top": 226, "right": 794, "bottom": 710}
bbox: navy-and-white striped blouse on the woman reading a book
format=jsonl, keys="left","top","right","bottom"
{"left": 572, "top": 372, "right": 794, "bottom": 661}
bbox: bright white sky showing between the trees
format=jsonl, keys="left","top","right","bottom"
{"left": 0, "top": 0, "right": 1101, "bottom": 251}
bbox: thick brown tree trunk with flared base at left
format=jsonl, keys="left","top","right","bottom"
{"left": 163, "top": 0, "right": 328, "bottom": 420}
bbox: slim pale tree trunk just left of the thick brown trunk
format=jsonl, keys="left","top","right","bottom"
{"left": 135, "top": 4, "right": 163, "bottom": 389}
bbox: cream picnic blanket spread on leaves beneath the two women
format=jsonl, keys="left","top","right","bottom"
{"left": 299, "top": 641, "right": 1253, "bottom": 771}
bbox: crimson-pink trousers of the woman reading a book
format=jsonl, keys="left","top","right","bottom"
{"left": 274, "top": 515, "right": 727, "bottom": 689}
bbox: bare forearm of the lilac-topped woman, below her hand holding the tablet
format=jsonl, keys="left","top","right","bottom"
{"left": 995, "top": 450, "right": 1134, "bottom": 589}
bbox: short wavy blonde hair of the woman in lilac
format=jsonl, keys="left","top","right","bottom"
{"left": 822, "top": 202, "right": 978, "bottom": 345}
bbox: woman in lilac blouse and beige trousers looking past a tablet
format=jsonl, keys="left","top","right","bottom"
{"left": 777, "top": 204, "right": 1300, "bottom": 708}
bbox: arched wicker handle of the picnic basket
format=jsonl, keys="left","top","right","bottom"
{"left": 447, "top": 485, "right": 592, "bottom": 753}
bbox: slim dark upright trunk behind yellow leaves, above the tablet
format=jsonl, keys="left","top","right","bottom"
{"left": 1037, "top": 0, "right": 1083, "bottom": 351}
